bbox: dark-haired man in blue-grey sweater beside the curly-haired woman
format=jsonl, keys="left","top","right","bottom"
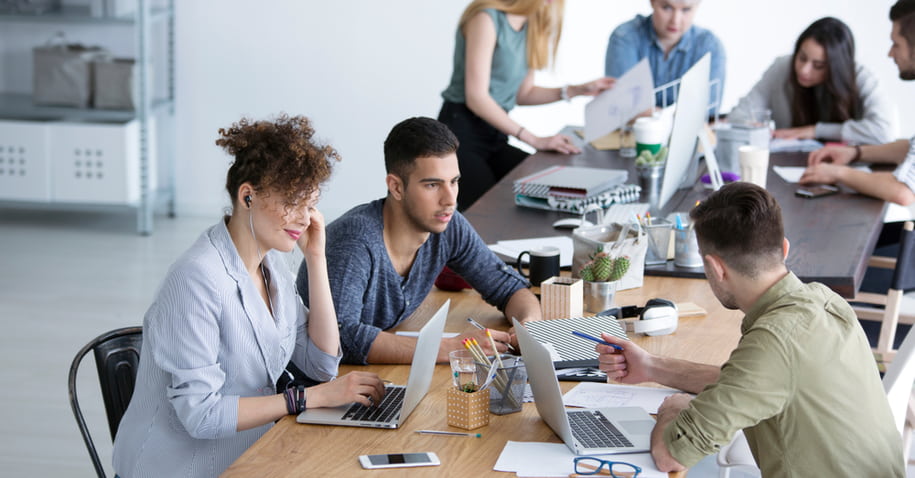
{"left": 297, "top": 118, "right": 541, "bottom": 364}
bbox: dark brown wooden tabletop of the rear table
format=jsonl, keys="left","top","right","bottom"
{"left": 464, "top": 145, "right": 886, "bottom": 298}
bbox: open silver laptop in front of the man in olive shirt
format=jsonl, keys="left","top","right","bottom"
{"left": 514, "top": 320, "right": 655, "bottom": 455}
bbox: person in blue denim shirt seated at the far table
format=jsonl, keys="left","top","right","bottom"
{"left": 604, "top": 0, "right": 727, "bottom": 107}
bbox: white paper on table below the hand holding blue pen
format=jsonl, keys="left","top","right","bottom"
{"left": 562, "top": 382, "right": 680, "bottom": 413}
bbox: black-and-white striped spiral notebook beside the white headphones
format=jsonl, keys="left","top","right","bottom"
{"left": 525, "top": 315, "right": 629, "bottom": 369}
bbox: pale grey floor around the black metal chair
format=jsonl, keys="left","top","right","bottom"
{"left": 0, "top": 209, "right": 915, "bottom": 478}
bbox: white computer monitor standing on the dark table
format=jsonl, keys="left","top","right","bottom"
{"left": 657, "top": 53, "right": 720, "bottom": 210}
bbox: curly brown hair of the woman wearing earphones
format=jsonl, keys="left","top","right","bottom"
{"left": 216, "top": 113, "right": 340, "bottom": 207}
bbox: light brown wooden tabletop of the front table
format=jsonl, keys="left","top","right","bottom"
{"left": 221, "top": 277, "right": 742, "bottom": 478}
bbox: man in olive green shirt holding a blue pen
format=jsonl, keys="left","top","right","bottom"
{"left": 598, "top": 182, "right": 905, "bottom": 477}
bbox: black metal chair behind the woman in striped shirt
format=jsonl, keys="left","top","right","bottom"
{"left": 69, "top": 327, "right": 143, "bottom": 478}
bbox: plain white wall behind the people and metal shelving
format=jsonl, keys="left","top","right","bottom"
{"left": 0, "top": 0, "right": 915, "bottom": 219}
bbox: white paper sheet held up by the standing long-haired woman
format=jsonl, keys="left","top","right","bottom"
{"left": 585, "top": 58, "right": 654, "bottom": 142}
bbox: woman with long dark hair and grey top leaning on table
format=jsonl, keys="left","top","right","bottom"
{"left": 728, "top": 17, "right": 897, "bottom": 144}
